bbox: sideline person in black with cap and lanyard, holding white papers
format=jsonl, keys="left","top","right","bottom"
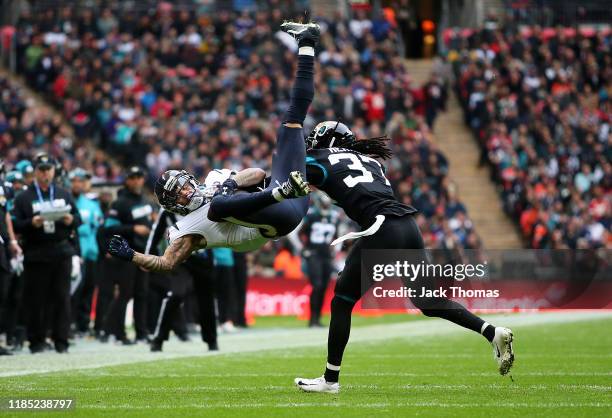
{"left": 14, "top": 153, "right": 80, "bottom": 353}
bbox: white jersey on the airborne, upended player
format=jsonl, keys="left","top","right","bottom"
{"left": 168, "top": 203, "right": 269, "bottom": 252}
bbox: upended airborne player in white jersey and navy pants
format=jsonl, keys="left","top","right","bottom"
{"left": 108, "top": 22, "right": 320, "bottom": 271}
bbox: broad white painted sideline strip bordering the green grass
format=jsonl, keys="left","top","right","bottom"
{"left": 0, "top": 311, "right": 612, "bottom": 377}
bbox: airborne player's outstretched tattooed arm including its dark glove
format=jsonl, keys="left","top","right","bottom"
{"left": 108, "top": 235, "right": 202, "bottom": 272}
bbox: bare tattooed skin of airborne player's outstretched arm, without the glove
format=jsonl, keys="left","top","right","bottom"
{"left": 132, "top": 235, "right": 202, "bottom": 271}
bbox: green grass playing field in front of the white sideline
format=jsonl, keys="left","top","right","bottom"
{"left": 0, "top": 316, "right": 612, "bottom": 417}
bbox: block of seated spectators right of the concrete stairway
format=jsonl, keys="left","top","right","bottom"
{"left": 446, "top": 25, "right": 612, "bottom": 249}
